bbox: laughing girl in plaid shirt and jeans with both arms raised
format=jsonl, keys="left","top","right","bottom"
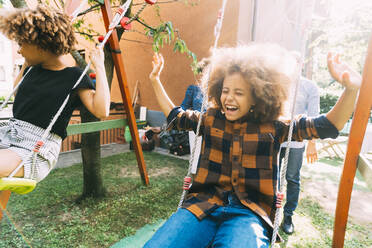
{"left": 144, "top": 44, "right": 361, "bottom": 248}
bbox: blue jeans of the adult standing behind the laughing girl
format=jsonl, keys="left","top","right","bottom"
{"left": 279, "top": 147, "right": 305, "bottom": 216}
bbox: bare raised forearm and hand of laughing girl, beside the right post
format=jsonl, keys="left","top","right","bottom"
{"left": 326, "top": 53, "right": 362, "bottom": 130}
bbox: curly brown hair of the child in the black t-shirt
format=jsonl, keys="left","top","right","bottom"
{"left": 0, "top": 5, "right": 76, "bottom": 55}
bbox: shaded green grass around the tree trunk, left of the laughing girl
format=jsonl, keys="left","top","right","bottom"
{"left": 0, "top": 153, "right": 188, "bottom": 247}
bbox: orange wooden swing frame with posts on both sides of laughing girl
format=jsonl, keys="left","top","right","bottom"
{"left": 0, "top": 0, "right": 372, "bottom": 248}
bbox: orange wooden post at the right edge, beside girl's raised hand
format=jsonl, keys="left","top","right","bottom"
{"left": 332, "top": 34, "right": 372, "bottom": 248}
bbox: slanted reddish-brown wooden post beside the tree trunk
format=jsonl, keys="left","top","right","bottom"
{"left": 101, "top": 0, "right": 149, "bottom": 185}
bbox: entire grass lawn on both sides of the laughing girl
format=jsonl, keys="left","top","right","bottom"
{"left": 0, "top": 152, "right": 372, "bottom": 248}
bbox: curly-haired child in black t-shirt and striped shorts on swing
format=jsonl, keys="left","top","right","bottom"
{"left": 0, "top": 5, "right": 110, "bottom": 182}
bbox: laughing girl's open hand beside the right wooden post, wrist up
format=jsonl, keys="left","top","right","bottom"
{"left": 327, "top": 53, "right": 362, "bottom": 89}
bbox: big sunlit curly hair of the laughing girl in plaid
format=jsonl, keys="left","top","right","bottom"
{"left": 202, "top": 43, "right": 297, "bottom": 123}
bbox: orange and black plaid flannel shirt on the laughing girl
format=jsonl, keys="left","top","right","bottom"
{"left": 168, "top": 107, "right": 338, "bottom": 232}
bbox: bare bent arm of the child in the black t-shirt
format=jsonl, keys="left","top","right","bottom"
{"left": 79, "top": 48, "right": 110, "bottom": 118}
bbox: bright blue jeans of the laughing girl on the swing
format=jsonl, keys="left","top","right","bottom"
{"left": 144, "top": 194, "right": 270, "bottom": 248}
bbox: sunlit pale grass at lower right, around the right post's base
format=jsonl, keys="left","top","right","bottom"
{"left": 279, "top": 157, "right": 372, "bottom": 248}
